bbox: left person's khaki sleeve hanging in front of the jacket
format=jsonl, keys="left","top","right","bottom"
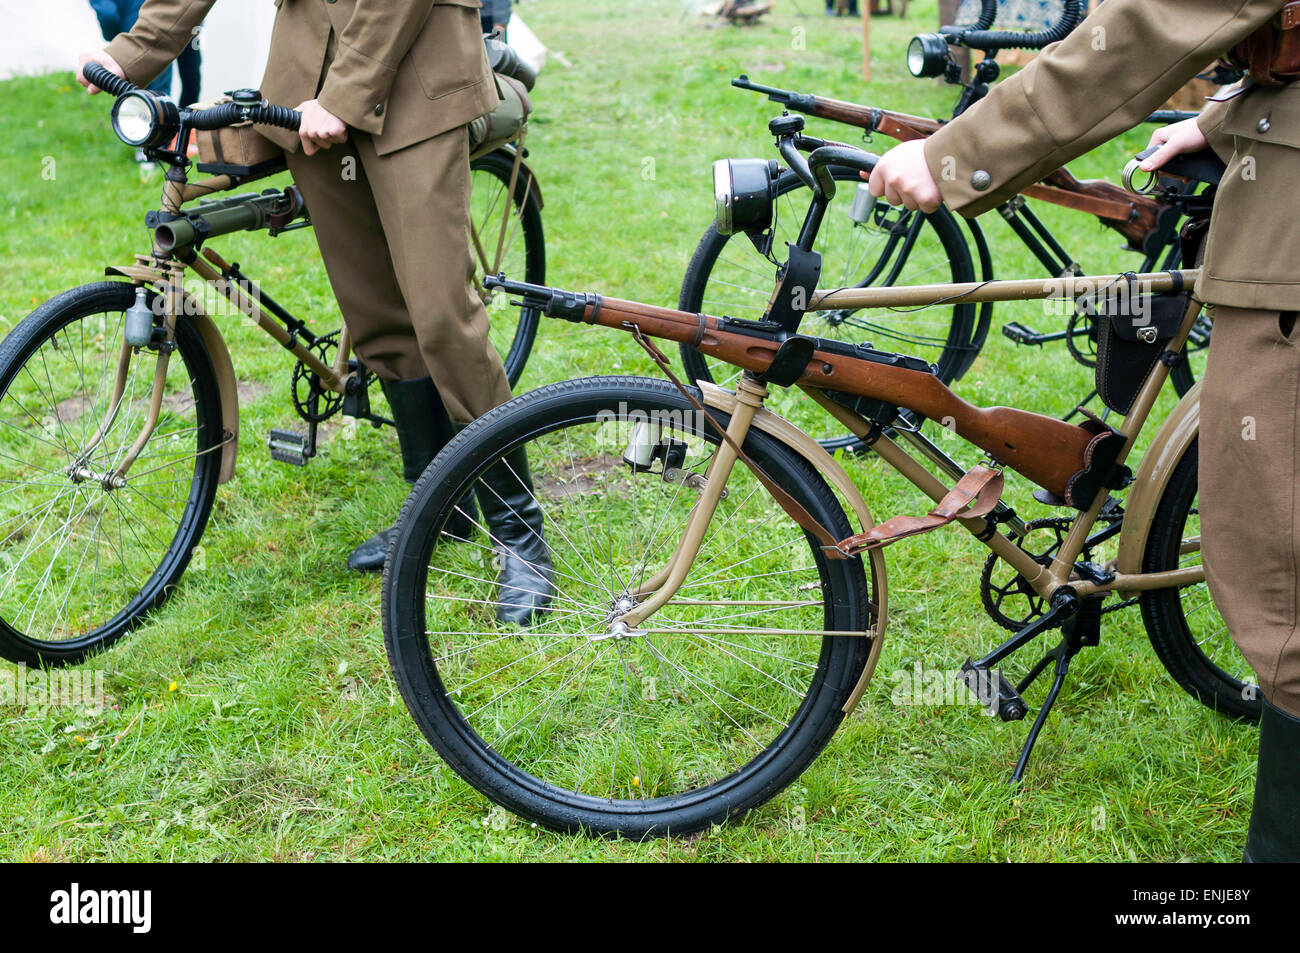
{"left": 316, "top": 0, "right": 433, "bottom": 135}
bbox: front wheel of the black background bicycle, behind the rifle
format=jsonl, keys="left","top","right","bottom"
{"left": 677, "top": 166, "right": 979, "bottom": 450}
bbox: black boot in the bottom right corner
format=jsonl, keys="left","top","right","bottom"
{"left": 1243, "top": 698, "right": 1300, "bottom": 863}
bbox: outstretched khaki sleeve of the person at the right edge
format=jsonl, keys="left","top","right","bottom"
{"left": 924, "top": 0, "right": 1281, "bottom": 216}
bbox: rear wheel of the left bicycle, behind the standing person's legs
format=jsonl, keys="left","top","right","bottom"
{"left": 469, "top": 148, "right": 546, "bottom": 387}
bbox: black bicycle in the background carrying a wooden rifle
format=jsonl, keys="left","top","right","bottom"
{"left": 677, "top": 0, "right": 1227, "bottom": 449}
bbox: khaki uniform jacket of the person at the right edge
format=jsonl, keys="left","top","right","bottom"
{"left": 924, "top": 0, "right": 1300, "bottom": 311}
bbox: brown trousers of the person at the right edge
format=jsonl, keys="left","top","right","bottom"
{"left": 1199, "top": 306, "right": 1300, "bottom": 716}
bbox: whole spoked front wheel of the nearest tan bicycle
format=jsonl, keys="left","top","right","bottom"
{"left": 384, "top": 377, "right": 871, "bottom": 837}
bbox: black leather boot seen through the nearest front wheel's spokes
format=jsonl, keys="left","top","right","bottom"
{"left": 478, "top": 447, "right": 555, "bottom": 625}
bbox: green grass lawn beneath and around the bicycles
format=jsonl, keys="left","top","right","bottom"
{"left": 0, "top": 0, "right": 1256, "bottom": 861}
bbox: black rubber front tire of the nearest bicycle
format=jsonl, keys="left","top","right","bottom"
{"left": 382, "top": 377, "right": 870, "bottom": 837}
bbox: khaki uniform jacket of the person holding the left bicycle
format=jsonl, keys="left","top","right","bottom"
{"left": 108, "top": 0, "right": 499, "bottom": 155}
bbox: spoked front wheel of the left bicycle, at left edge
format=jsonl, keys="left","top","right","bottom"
{"left": 0, "top": 281, "right": 224, "bottom": 664}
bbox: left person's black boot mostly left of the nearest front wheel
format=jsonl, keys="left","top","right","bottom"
{"left": 347, "top": 377, "right": 477, "bottom": 572}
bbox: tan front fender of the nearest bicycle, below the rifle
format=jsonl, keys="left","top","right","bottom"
{"left": 696, "top": 381, "right": 889, "bottom": 715}
